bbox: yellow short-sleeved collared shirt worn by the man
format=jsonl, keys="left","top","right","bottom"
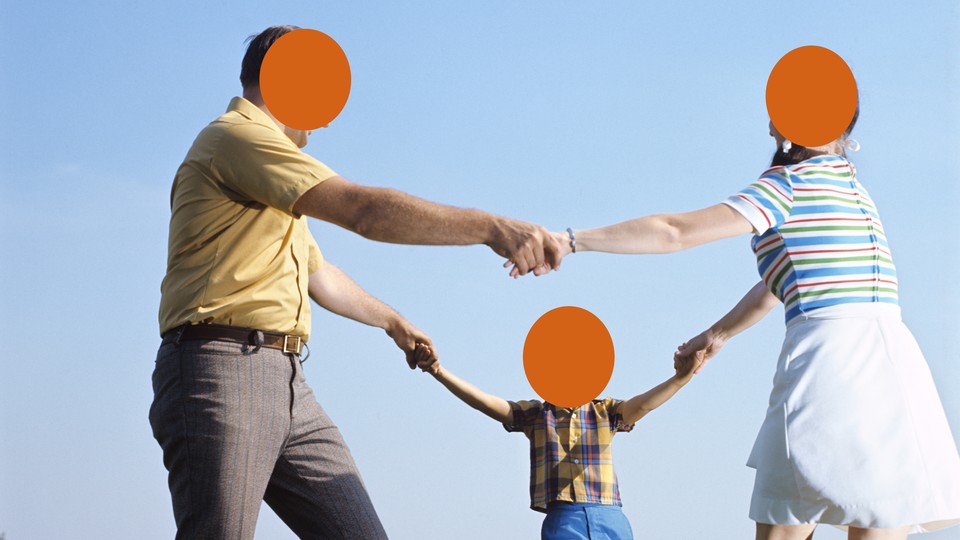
{"left": 160, "top": 97, "right": 336, "bottom": 339}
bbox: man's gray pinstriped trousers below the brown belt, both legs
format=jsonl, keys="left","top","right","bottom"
{"left": 150, "top": 339, "right": 387, "bottom": 540}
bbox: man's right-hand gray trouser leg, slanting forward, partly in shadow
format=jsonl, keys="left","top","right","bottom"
{"left": 264, "top": 363, "right": 387, "bottom": 540}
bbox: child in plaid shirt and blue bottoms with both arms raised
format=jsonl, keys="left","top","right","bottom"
{"left": 414, "top": 344, "right": 701, "bottom": 540}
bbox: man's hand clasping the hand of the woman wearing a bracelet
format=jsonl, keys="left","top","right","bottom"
{"left": 487, "top": 218, "right": 563, "bottom": 278}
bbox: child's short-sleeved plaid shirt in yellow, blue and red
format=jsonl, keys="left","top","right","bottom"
{"left": 503, "top": 398, "right": 633, "bottom": 512}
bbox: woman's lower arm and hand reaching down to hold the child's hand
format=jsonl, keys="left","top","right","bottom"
{"left": 674, "top": 281, "right": 780, "bottom": 373}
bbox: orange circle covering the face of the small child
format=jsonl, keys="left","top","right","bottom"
{"left": 523, "top": 306, "right": 614, "bottom": 408}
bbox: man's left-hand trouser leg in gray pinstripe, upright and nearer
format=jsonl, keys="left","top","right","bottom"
{"left": 150, "top": 341, "right": 293, "bottom": 539}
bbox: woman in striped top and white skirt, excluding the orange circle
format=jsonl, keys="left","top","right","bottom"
{"left": 538, "top": 108, "right": 960, "bottom": 540}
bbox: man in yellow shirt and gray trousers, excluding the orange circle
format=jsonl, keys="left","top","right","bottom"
{"left": 150, "top": 26, "right": 559, "bottom": 539}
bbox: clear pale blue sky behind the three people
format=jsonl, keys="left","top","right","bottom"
{"left": 0, "top": 0, "right": 960, "bottom": 540}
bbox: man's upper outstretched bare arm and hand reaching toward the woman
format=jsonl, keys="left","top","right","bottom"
{"left": 293, "top": 176, "right": 560, "bottom": 275}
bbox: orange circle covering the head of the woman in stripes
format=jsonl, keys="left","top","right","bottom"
{"left": 767, "top": 45, "right": 857, "bottom": 146}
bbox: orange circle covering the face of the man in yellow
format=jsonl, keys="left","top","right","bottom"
{"left": 260, "top": 28, "right": 350, "bottom": 130}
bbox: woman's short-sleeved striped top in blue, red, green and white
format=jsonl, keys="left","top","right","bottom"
{"left": 723, "top": 155, "right": 897, "bottom": 322}
